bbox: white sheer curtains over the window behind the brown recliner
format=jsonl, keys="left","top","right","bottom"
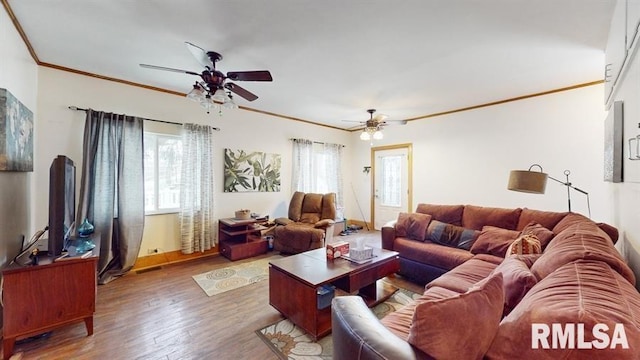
{"left": 291, "top": 139, "right": 343, "bottom": 206}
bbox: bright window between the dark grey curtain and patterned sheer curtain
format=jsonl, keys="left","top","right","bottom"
{"left": 144, "top": 132, "right": 182, "bottom": 214}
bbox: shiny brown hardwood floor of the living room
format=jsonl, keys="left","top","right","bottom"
{"left": 6, "top": 232, "right": 422, "bottom": 360}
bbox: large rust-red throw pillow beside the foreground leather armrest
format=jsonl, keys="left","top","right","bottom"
{"left": 407, "top": 273, "right": 504, "bottom": 359}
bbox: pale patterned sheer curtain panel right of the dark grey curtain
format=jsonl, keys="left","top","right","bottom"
{"left": 180, "top": 124, "right": 215, "bottom": 254}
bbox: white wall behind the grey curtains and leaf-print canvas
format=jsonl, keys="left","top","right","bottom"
{"left": 34, "top": 67, "right": 350, "bottom": 256}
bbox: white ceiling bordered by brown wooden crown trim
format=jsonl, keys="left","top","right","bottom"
{"left": 3, "top": 0, "right": 615, "bottom": 128}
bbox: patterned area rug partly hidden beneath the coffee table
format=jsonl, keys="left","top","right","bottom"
{"left": 256, "top": 289, "right": 420, "bottom": 360}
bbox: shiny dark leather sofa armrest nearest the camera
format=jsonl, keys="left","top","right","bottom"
{"left": 331, "top": 296, "right": 428, "bottom": 360}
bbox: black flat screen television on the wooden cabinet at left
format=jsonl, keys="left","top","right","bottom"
{"left": 48, "top": 155, "right": 76, "bottom": 256}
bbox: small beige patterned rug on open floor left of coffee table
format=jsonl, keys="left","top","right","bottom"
{"left": 192, "top": 255, "right": 281, "bottom": 296}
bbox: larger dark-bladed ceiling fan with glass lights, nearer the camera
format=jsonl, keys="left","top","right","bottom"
{"left": 140, "top": 41, "right": 273, "bottom": 113}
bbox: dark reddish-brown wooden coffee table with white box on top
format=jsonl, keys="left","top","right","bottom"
{"left": 269, "top": 248, "right": 400, "bottom": 339}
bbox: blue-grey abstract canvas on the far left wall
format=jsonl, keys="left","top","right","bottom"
{"left": 0, "top": 89, "right": 33, "bottom": 171}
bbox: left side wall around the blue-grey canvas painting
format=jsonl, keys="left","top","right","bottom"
{"left": 0, "top": 6, "right": 39, "bottom": 267}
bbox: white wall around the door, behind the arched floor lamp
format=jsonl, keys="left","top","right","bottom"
{"left": 345, "top": 85, "right": 612, "bottom": 222}
